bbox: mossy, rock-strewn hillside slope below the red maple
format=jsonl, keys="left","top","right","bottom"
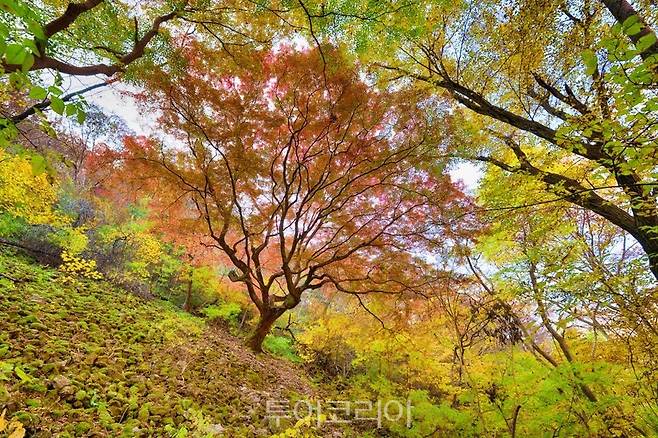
{"left": 0, "top": 253, "right": 326, "bottom": 437}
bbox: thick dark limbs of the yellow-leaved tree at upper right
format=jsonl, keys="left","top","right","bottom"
{"left": 404, "top": 31, "right": 658, "bottom": 280}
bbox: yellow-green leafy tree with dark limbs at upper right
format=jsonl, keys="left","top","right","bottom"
{"left": 284, "top": 0, "right": 658, "bottom": 278}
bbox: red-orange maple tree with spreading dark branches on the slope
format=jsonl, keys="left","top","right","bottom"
{"left": 123, "top": 47, "right": 463, "bottom": 350}
